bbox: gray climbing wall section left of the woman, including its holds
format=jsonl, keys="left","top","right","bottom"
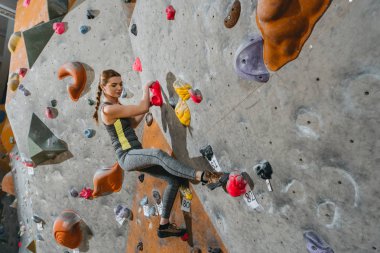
{"left": 6, "top": 0, "right": 142, "bottom": 253}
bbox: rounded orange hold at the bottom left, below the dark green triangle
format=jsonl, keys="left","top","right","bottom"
{"left": 53, "top": 210, "right": 83, "bottom": 249}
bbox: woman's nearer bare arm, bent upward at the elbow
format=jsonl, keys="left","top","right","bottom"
{"left": 103, "top": 82, "right": 153, "bottom": 119}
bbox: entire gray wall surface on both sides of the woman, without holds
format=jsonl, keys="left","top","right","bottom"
{"left": 2, "top": 0, "right": 380, "bottom": 253}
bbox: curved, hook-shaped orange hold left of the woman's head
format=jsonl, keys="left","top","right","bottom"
{"left": 58, "top": 62, "right": 87, "bottom": 101}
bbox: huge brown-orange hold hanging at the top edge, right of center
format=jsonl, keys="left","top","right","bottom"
{"left": 256, "top": 0, "right": 330, "bottom": 71}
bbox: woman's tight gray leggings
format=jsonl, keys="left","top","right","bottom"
{"left": 118, "top": 149, "right": 195, "bottom": 219}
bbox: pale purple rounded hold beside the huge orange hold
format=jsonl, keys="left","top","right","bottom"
{"left": 234, "top": 35, "right": 269, "bottom": 83}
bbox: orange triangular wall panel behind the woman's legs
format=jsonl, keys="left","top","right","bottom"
{"left": 126, "top": 121, "right": 227, "bottom": 253}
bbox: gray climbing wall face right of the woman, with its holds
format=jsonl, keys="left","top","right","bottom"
{"left": 130, "top": 0, "right": 380, "bottom": 253}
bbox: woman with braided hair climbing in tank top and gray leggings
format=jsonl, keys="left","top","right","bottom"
{"left": 93, "top": 69, "right": 224, "bottom": 238}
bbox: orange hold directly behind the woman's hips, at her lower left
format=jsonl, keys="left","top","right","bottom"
{"left": 92, "top": 162, "right": 124, "bottom": 198}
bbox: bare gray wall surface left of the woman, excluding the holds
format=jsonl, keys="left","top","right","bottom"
{"left": 6, "top": 1, "right": 141, "bottom": 253}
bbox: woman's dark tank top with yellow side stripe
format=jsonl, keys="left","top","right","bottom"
{"left": 101, "top": 102, "right": 142, "bottom": 157}
